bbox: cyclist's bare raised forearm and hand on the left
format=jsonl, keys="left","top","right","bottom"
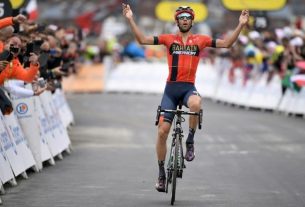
{"left": 122, "top": 4, "right": 154, "bottom": 45}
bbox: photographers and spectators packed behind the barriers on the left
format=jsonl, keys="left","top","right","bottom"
{"left": 0, "top": 14, "right": 82, "bottom": 114}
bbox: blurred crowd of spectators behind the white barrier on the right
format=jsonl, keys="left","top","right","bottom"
{"left": 207, "top": 26, "right": 305, "bottom": 93}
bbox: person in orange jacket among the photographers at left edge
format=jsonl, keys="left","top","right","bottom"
{"left": 0, "top": 36, "right": 39, "bottom": 85}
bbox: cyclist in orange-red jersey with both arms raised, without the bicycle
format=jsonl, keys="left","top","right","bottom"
{"left": 122, "top": 4, "right": 249, "bottom": 192}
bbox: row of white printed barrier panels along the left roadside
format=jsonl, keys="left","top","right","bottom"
{"left": 0, "top": 86, "right": 74, "bottom": 204}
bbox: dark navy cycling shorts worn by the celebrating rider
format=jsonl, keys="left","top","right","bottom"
{"left": 161, "top": 82, "right": 200, "bottom": 123}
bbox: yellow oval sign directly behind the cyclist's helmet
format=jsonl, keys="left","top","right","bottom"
{"left": 155, "top": 1, "right": 208, "bottom": 22}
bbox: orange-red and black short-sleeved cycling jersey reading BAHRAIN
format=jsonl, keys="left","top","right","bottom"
{"left": 154, "top": 34, "right": 216, "bottom": 84}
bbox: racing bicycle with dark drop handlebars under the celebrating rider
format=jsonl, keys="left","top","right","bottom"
{"left": 155, "top": 103, "right": 202, "bottom": 205}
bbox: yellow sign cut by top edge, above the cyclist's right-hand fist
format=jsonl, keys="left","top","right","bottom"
{"left": 222, "top": 0, "right": 287, "bottom": 11}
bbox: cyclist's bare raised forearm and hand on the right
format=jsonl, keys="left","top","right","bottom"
{"left": 216, "top": 10, "right": 249, "bottom": 48}
